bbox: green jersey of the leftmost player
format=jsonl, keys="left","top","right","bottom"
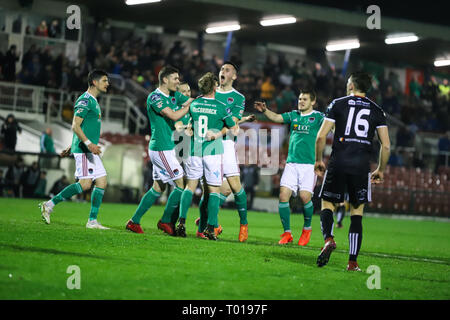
{"left": 71, "top": 91, "right": 102, "bottom": 153}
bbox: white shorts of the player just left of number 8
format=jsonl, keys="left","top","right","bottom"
{"left": 148, "top": 150, "right": 184, "bottom": 185}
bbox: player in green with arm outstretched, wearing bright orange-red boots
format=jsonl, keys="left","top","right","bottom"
{"left": 255, "top": 90, "right": 324, "bottom": 246}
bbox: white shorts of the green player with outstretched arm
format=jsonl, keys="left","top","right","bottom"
{"left": 280, "top": 162, "right": 317, "bottom": 197}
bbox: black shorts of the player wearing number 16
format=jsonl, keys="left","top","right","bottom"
{"left": 319, "top": 167, "right": 372, "bottom": 207}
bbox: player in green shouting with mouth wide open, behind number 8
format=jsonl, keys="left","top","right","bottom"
{"left": 198, "top": 61, "right": 255, "bottom": 242}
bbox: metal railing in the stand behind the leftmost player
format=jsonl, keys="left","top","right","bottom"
{"left": 0, "top": 82, "right": 147, "bottom": 133}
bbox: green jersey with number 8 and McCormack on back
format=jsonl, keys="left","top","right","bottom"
{"left": 189, "top": 97, "right": 235, "bottom": 157}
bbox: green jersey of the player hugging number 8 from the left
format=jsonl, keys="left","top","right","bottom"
{"left": 147, "top": 89, "right": 189, "bottom": 151}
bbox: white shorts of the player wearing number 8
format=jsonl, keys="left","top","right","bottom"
{"left": 185, "top": 154, "right": 223, "bottom": 187}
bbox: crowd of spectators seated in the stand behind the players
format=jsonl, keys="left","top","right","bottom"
{"left": 0, "top": 26, "right": 450, "bottom": 134}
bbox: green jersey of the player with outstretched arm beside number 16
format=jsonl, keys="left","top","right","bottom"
{"left": 281, "top": 110, "right": 325, "bottom": 164}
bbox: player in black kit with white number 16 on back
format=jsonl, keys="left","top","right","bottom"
{"left": 314, "top": 72, "right": 390, "bottom": 271}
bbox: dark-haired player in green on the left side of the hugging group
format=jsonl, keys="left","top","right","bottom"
{"left": 126, "top": 66, "right": 193, "bottom": 235}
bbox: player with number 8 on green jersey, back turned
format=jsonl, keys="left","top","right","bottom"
{"left": 176, "top": 72, "right": 239, "bottom": 240}
